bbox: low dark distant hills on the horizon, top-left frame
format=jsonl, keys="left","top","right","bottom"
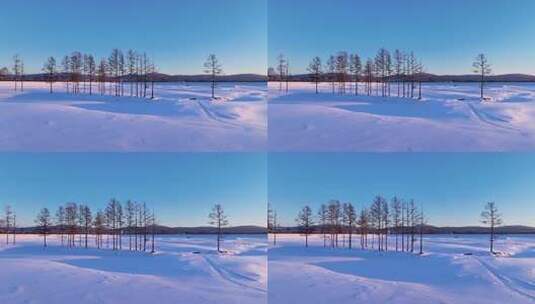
{"left": 0, "top": 73, "right": 267, "bottom": 82}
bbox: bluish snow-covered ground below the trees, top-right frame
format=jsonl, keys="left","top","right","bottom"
{"left": 268, "top": 82, "right": 535, "bottom": 152}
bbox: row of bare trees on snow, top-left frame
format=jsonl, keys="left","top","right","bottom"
{"left": 0, "top": 52, "right": 223, "bottom": 99}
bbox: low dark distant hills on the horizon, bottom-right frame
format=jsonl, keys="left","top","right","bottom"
{"left": 278, "top": 225, "right": 535, "bottom": 234}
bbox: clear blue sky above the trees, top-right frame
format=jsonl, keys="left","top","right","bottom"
{"left": 268, "top": 0, "right": 535, "bottom": 74}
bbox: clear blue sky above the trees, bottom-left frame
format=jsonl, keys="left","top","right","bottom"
{"left": 0, "top": 153, "right": 267, "bottom": 226}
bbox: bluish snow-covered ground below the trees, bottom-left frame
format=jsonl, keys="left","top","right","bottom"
{"left": 0, "top": 235, "right": 267, "bottom": 304}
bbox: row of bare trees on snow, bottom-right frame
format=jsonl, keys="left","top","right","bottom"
{"left": 267, "top": 200, "right": 503, "bottom": 254}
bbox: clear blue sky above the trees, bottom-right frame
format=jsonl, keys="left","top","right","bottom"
{"left": 268, "top": 153, "right": 535, "bottom": 226}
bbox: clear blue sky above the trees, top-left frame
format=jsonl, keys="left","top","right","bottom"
{"left": 0, "top": 0, "right": 267, "bottom": 74}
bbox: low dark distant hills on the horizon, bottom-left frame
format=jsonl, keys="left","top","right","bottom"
{"left": 15, "top": 225, "right": 267, "bottom": 234}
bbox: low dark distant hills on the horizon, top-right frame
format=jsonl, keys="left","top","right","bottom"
{"left": 269, "top": 73, "right": 535, "bottom": 82}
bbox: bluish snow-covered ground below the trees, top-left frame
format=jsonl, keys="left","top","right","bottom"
{"left": 0, "top": 82, "right": 267, "bottom": 152}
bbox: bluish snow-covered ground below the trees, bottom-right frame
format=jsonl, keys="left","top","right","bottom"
{"left": 268, "top": 235, "right": 535, "bottom": 304}
